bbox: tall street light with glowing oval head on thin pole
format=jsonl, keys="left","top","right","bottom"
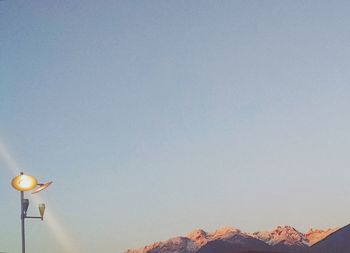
{"left": 11, "top": 172, "right": 52, "bottom": 253}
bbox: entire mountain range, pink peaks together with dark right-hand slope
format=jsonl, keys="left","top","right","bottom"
{"left": 125, "top": 225, "right": 350, "bottom": 253}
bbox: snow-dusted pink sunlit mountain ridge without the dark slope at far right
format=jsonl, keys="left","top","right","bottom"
{"left": 125, "top": 225, "right": 338, "bottom": 253}
